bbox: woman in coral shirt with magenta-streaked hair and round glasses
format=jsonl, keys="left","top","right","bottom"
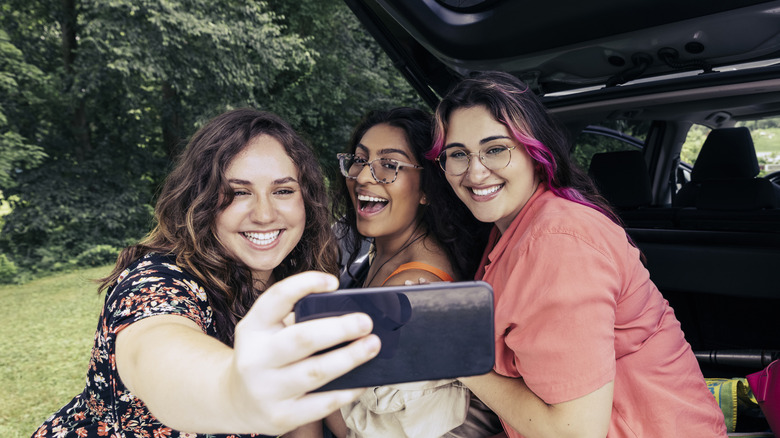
{"left": 427, "top": 72, "right": 726, "bottom": 438}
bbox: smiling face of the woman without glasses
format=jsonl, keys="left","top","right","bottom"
{"left": 216, "top": 135, "right": 306, "bottom": 282}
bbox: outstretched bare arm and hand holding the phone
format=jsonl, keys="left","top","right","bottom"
{"left": 116, "top": 272, "right": 380, "bottom": 434}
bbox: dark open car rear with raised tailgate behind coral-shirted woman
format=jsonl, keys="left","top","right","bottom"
{"left": 346, "top": 0, "right": 780, "bottom": 436}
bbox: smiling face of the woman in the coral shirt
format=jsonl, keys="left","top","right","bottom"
{"left": 444, "top": 106, "right": 539, "bottom": 233}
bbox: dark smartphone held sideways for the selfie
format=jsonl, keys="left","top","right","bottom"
{"left": 295, "top": 281, "right": 495, "bottom": 391}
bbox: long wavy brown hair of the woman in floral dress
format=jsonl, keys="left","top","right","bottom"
{"left": 100, "top": 109, "right": 338, "bottom": 345}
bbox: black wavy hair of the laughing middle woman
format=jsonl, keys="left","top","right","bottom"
{"left": 332, "top": 107, "right": 489, "bottom": 279}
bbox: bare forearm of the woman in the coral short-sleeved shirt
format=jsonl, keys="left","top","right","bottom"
{"left": 461, "top": 371, "right": 612, "bottom": 438}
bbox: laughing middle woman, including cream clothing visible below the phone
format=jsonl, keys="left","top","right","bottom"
{"left": 284, "top": 108, "right": 501, "bottom": 438}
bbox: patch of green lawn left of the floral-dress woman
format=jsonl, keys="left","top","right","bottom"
{"left": 0, "top": 266, "right": 111, "bottom": 438}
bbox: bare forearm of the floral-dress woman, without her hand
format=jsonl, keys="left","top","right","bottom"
{"left": 117, "top": 316, "right": 251, "bottom": 433}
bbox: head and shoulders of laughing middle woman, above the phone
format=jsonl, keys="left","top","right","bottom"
{"left": 333, "top": 108, "right": 494, "bottom": 287}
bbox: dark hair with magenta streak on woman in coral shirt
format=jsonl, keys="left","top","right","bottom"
{"left": 427, "top": 72, "right": 622, "bottom": 226}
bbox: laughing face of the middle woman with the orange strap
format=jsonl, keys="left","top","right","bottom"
{"left": 347, "top": 124, "right": 425, "bottom": 242}
